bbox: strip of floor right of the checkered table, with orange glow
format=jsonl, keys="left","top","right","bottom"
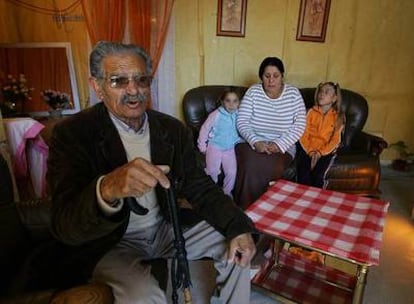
{"left": 364, "top": 172, "right": 414, "bottom": 304}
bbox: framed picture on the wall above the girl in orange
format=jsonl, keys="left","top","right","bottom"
{"left": 296, "top": 0, "right": 331, "bottom": 42}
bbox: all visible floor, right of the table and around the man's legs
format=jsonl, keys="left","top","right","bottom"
{"left": 167, "top": 168, "right": 414, "bottom": 304}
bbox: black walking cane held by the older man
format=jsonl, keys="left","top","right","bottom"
{"left": 166, "top": 178, "right": 192, "bottom": 304}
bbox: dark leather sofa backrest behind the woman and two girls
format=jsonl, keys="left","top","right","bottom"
{"left": 182, "top": 85, "right": 368, "bottom": 147}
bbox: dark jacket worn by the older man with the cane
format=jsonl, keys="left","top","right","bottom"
{"left": 47, "top": 103, "right": 254, "bottom": 286}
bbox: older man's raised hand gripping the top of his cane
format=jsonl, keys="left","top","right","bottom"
{"left": 100, "top": 158, "right": 170, "bottom": 202}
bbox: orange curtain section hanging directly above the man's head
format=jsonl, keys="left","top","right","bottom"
{"left": 82, "top": 0, "right": 126, "bottom": 45}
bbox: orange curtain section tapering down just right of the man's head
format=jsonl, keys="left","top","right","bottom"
{"left": 128, "top": 0, "right": 174, "bottom": 74}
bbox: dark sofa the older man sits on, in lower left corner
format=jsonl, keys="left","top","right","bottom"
{"left": 0, "top": 153, "right": 168, "bottom": 304}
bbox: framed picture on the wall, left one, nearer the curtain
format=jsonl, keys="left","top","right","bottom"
{"left": 217, "top": 0, "right": 247, "bottom": 37}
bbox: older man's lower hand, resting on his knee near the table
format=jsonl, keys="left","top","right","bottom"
{"left": 227, "top": 233, "right": 256, "bottom": 267}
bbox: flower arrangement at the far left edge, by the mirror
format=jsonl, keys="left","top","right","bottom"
{"left": 0, "top": 74, "right": 34, "bottom": 117}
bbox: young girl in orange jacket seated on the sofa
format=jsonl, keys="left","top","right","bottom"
{"left": 296, "top": 82, "right": 345, "bottom": 188}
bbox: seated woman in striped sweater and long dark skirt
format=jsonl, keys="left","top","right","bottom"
{"left": 234, "top": 57, "right": 306, "bottom": 209}
